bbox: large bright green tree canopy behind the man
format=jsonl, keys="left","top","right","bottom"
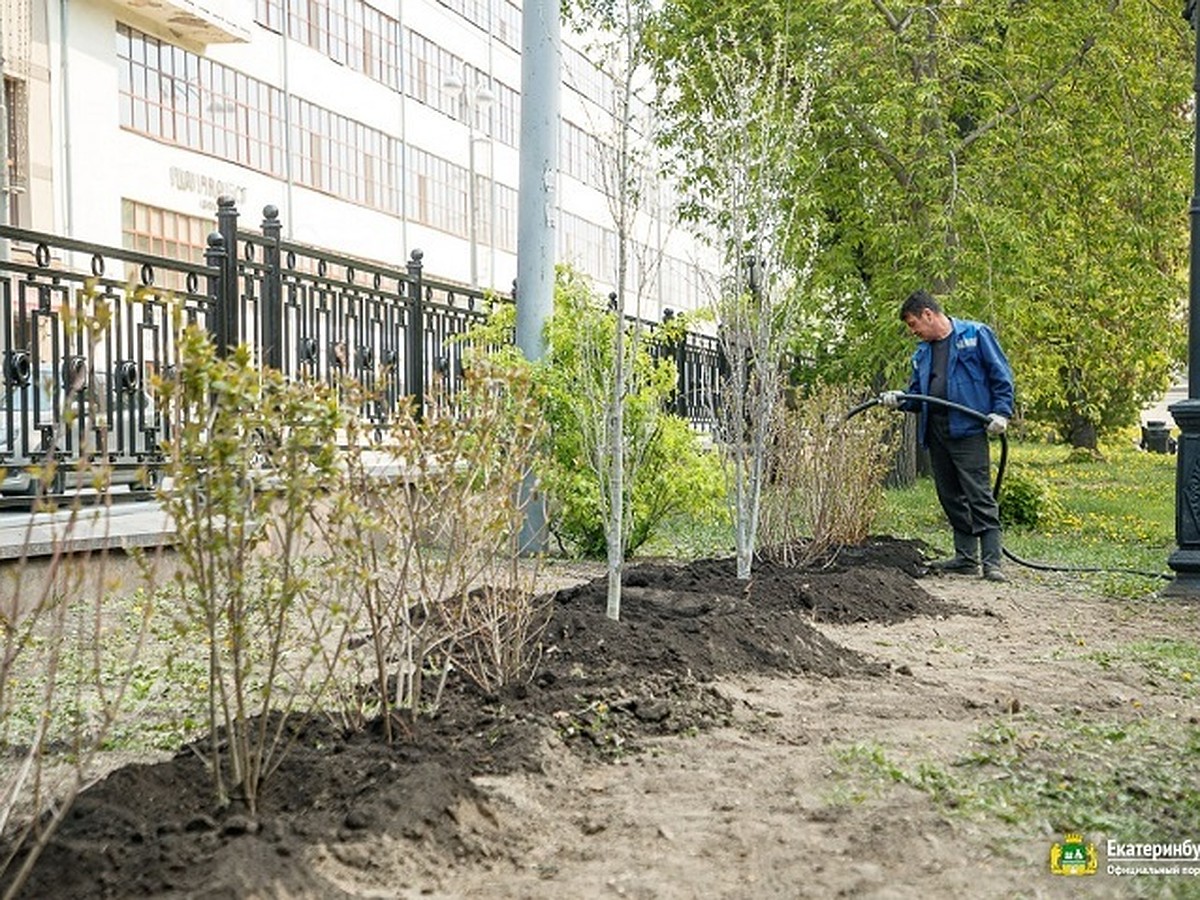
{"left": 650, "top": 0, "right": 1193, "bottom": 445}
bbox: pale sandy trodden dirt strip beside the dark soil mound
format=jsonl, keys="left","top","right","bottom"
{"left": 400, "top": 575, "right": 1200, "bottom": 899}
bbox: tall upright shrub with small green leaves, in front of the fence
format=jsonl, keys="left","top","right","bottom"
{"left": 161, "top": 325, "right": 342, "bottom": 814}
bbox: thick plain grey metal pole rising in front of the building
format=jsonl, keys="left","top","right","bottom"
{"left": 516, "top": 0, "right": 562, "bottom": 552}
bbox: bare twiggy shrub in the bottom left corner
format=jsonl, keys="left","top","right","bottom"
{"left": 0, "top": 480, "right": 154, "bottom": 898}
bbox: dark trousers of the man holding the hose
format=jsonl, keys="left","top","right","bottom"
{"left": 925, "top": 415, "right": 1000, "bottom": 535}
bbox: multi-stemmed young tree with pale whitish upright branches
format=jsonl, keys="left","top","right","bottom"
{"left": 676, "top": 32, "right": 816, "bottom": 580}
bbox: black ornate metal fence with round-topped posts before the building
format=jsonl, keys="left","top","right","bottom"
{"left": 0, "top": 204, "right": 720, "bottom": 505}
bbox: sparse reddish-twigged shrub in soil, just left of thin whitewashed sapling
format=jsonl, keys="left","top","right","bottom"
{"left": 329, "top": 360, "right": 542, "bottom": 740}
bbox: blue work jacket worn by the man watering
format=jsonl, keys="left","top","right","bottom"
{"left": 902, "top": 317, "right": 1013, "bottom": 446}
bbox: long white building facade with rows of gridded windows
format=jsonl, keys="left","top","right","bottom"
{"left": 0, "top": 0, "right": 706, "bottom": 319}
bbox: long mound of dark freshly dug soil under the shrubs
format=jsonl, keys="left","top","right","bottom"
{"left": 0, "top": 539, "right": 962, "bottom": 898}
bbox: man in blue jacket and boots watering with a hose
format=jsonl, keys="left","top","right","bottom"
{"left": 881, "top": 290, "right": 1013, "bottom": 581}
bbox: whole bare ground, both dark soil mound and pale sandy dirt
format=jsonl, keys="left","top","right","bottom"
{"left": 4, "top": 539, "right": 1200, "bottom": 900}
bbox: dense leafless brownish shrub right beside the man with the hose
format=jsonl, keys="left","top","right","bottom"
{"left": 762, "top": 385, "right": 893, "bottom": 565}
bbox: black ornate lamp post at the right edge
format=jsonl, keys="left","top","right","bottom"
{"left": 1163, "top": 0, "right": 1200, "bottom": 599}
